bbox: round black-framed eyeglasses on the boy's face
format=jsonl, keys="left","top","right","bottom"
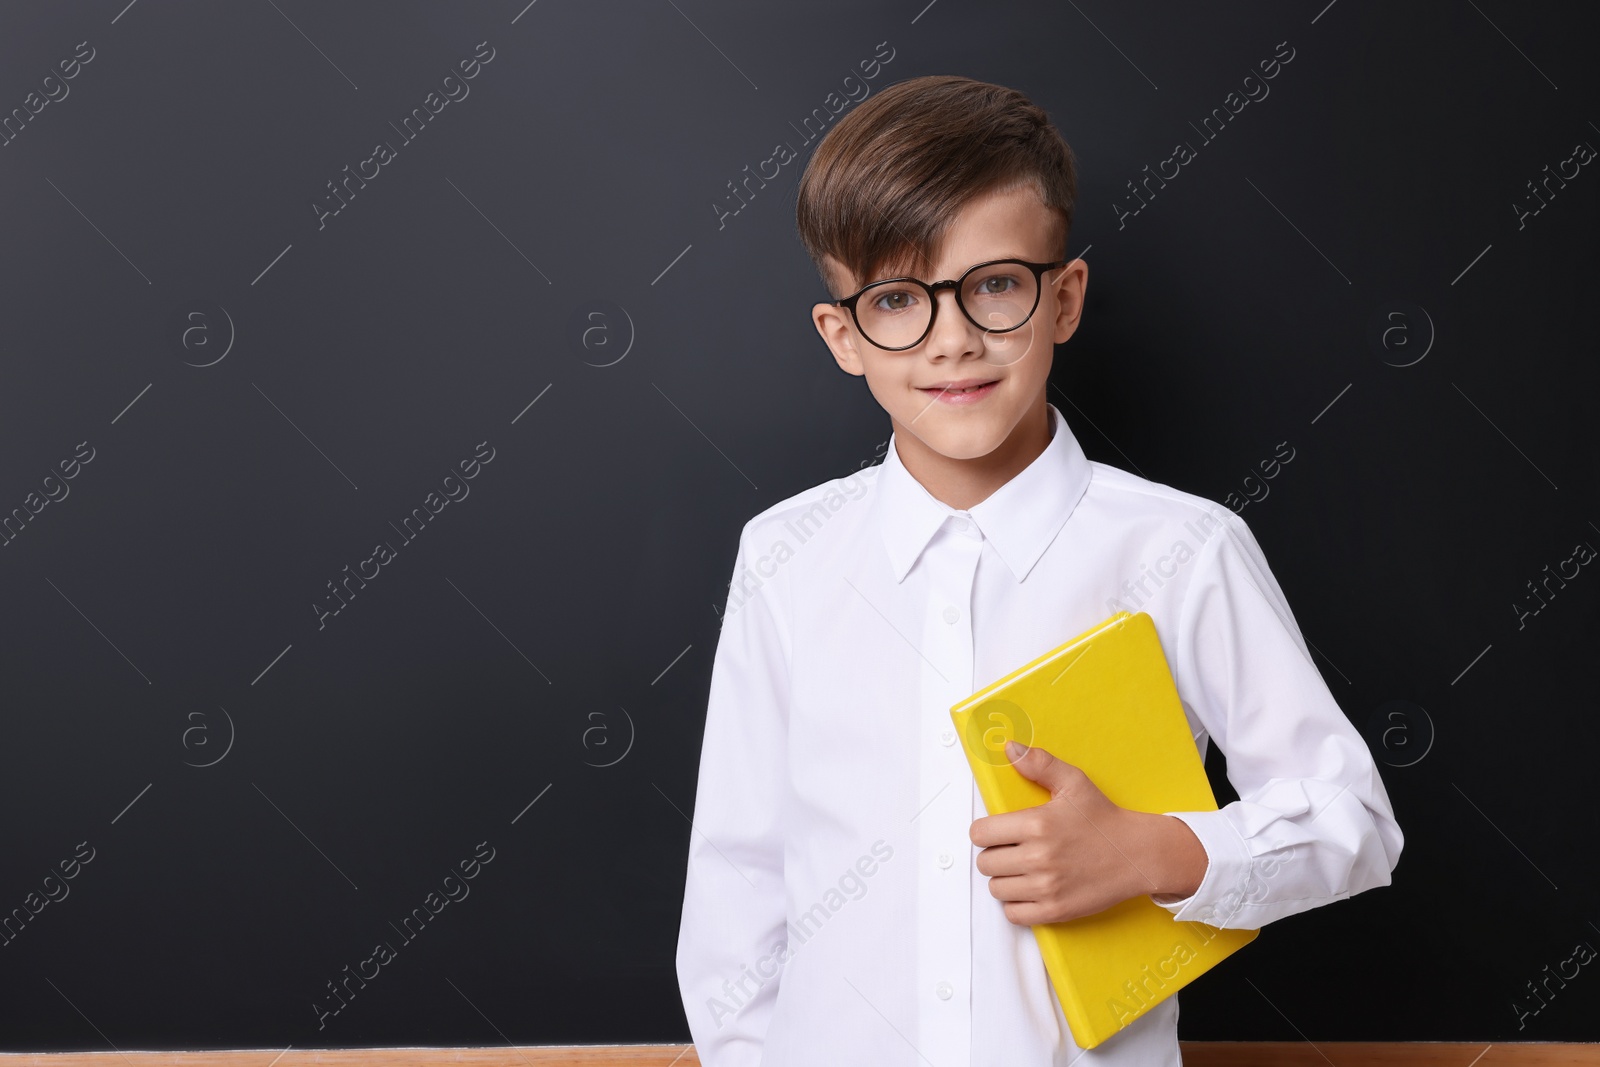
{"left": 834, "top": 259, "right": 1070, "bottom": 352}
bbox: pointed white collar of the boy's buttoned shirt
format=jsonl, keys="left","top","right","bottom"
{"left": 874, "top": 402, "right": 1090, "bottom": 582}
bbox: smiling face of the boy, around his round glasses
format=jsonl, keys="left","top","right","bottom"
{"left": 811, "top": 184, "right": 1088, "bottom": 462}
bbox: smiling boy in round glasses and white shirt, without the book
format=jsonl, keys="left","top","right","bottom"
{"left": 677, "top": 75, "right": 1403, "bottom": 1067}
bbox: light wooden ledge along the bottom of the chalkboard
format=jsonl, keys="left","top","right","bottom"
{"left": 0, "top": 1041, "right": 1600, "bottom": 1067}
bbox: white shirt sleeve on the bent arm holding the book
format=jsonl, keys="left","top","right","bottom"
{"left": 1157, "top": 512, "right": 1405, "bottom": 929}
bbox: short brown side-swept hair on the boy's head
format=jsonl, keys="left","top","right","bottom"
{"left": 795, "top": 74, "right": 1077, "bottom": 296}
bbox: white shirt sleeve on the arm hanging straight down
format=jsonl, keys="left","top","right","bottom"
{"left": 677, "top": 520, "right": 789, "bottom": 1067}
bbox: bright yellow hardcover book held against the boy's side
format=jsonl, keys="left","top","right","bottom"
{"left": 950, "top": 611, "right": 1261, "bottom": 1048}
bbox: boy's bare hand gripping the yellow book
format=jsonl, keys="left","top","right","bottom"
{"left": 971, "top": 741, "right": 1208, "bottom": 926}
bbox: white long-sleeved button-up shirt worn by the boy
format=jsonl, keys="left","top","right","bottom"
{"left": 677, "top": 405, "right": 1403, "bottom": 1067}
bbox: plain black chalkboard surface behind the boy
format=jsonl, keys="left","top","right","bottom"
{"left": 0, "top": 0, "right": 1600, "bottom": 1051}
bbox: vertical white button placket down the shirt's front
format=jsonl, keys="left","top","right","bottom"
{"left": 915, "top": 515, "right": 982, "bottom": 1067}
